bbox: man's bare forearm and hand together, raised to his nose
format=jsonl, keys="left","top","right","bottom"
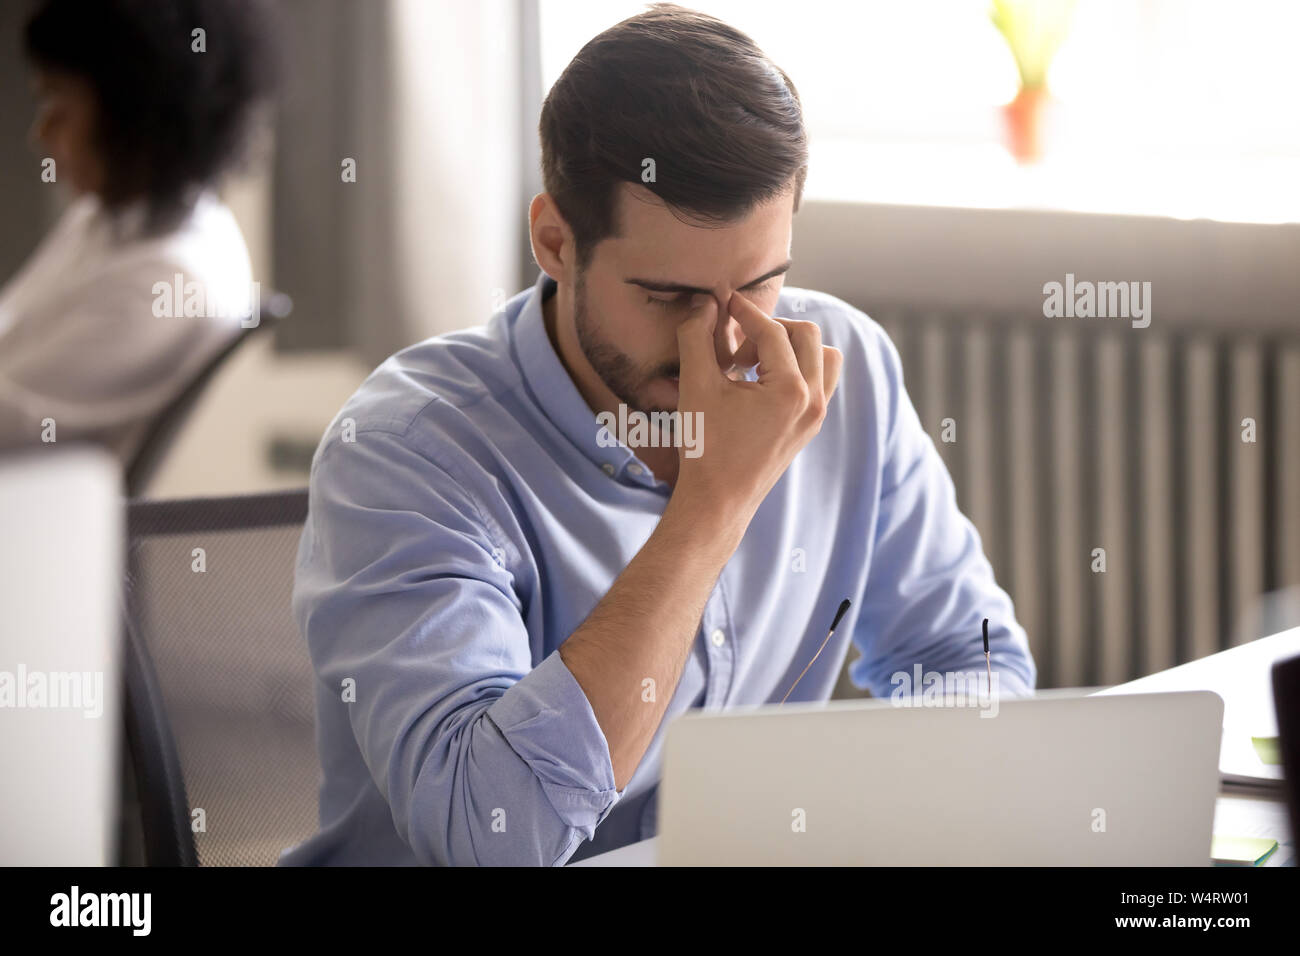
{"left": 560, "top": 294, "right": 844, "bottom": 791}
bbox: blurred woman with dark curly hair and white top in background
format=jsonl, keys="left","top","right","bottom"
{"left": 0, "top": 0, "right": 276, "bottom": 464}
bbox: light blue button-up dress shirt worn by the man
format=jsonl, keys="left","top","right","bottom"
{"left": 281, "top": 274, "right": 1036, "bottom": 865}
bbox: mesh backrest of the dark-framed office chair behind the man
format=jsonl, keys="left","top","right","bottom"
{"left": 121, "top": 489, "right": 320, "bottom": 866}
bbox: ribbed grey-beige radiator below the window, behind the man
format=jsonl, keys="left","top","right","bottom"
{"left": 872, "top": 310, "right": 1300, "bottom": 687}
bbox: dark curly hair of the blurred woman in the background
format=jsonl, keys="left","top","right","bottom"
{"left": 25, "top": 0, "right": 280, "bottom": 229}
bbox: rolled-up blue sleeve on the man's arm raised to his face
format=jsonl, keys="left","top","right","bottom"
{"left": 294, "top": 431, "right": 620, "bottom": 865}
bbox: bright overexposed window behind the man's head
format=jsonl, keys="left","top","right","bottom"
{"left": 540, "top": 0, "right": 1300, "bottom": 222}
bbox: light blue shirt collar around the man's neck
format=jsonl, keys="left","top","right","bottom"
{"left": 515, "top": 272, "right": 640, "bottom": 476}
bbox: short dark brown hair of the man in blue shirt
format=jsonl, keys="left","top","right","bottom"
{"left": 538, "top": 4, "right": 809, "bottom": 268}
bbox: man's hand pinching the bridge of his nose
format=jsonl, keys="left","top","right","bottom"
{"left": 673, "top": 293, "right": 844, "bottom": 533}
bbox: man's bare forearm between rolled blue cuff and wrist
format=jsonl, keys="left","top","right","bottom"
{"left": 560, "top": 497, "right": 746, "bottom": 791}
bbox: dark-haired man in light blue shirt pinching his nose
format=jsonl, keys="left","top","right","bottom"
{"left": 282, "top": 7, "right": 1035, "bottom": 865}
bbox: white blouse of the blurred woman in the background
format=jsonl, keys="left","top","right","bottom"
{"left": 0, "top": 193, "right": 256, "bottom": 466}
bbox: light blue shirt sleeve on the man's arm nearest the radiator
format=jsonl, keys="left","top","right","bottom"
{"left": 850, "top": 317, "right": 1037, "bottom": 697}
